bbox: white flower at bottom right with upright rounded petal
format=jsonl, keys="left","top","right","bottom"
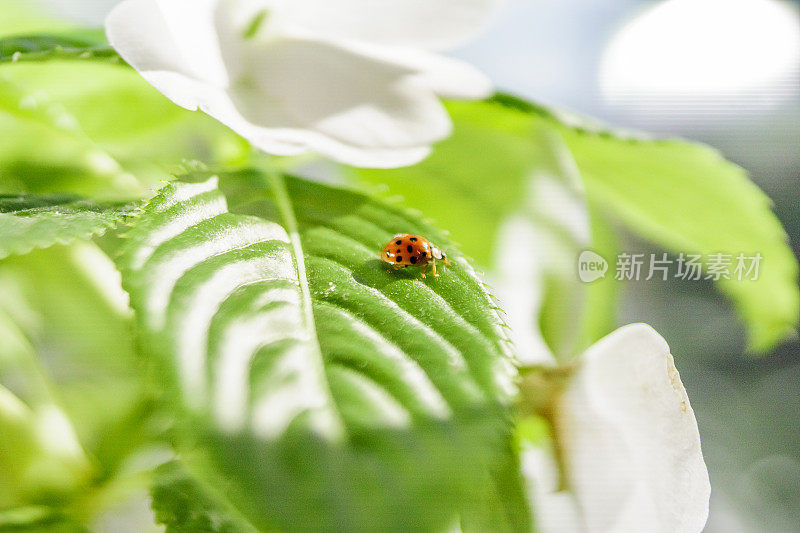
{"left": 523, "top": 324, "right": 711, "bottom": 533}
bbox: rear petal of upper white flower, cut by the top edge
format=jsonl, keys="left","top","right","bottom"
{"left": 273, "top": 0, "right": 499, "bottom": 50}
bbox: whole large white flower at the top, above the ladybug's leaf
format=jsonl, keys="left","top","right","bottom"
{"left": 106, "top": 0, "right": 496, "bottom": 167}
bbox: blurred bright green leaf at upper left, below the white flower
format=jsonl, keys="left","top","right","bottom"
{"left": 0, "top": 55, "right": 250, "bottom": 195}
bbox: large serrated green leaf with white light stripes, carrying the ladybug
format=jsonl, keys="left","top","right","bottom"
{"left": 119, "top": 171, "right": 529, "bottom": 531}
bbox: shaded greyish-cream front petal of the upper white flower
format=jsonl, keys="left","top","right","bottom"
{"left": 231, "top": 37, "right": 451, "bottom": 149}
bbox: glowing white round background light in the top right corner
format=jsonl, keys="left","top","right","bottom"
{"left": 600, "top": 0, "right": 800, "bottom": 105}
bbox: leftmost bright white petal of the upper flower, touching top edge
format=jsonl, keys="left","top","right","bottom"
{"left": 106, "top": 0, "right": 227, "bottom": 86}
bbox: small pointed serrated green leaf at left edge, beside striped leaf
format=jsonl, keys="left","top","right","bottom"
{"left": 0, "top": 194, "right": 134, "bottom": 259}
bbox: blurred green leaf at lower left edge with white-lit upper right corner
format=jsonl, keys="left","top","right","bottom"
{"left": 0, "top": 242, "right": 153, "bottom": 479}
